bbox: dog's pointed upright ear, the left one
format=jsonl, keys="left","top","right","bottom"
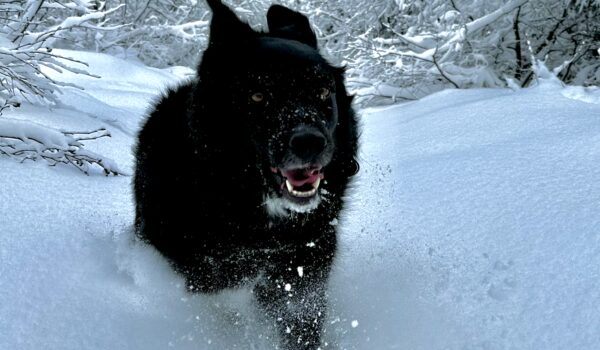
{"left": 206, "top": 0, "right": 256, "bottom": 46}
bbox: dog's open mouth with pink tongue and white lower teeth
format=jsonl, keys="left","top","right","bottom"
{"left": 271, "top": 165, "right": 325, "bottom": 202}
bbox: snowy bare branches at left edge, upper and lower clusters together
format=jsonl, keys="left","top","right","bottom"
{"left": 0, "top": 0, "right": 122, "bottom": 175}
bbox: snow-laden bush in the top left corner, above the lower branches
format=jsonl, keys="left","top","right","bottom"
{"left": 0, "top": 0, "right": 122, "bottom": 113}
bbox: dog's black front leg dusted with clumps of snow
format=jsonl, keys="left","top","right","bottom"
{"left": 255, "top": 247, "right": 333, "bottom": 350}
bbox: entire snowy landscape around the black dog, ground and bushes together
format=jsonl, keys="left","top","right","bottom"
{"left": 0, "top": 0, "right": 600, "bottom": 350}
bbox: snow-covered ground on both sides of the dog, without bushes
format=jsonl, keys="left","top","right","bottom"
{"left": 0, "top": 52, "right": 600, "bottom": 350}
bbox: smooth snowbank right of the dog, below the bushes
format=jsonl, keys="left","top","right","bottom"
{"left": 334, "top": 82, "right": 600, "bottom": 349}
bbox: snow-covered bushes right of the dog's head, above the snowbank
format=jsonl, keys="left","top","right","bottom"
{"left": 302, "top": 0, "right": 600, "bottom": 102}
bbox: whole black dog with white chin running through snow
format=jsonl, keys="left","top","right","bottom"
{"left": 134, "top": 0, "right": 358, "bottom": 349}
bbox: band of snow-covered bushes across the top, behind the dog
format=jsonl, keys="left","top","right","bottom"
{"left": 0, "top": 0, "right": 600, "bottom": 113}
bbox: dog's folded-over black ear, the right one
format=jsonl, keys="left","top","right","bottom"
{"left": 267, "top": 5, "right": 317, "bottom": 49}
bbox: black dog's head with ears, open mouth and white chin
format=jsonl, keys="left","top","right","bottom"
{"left": 199, "top": 0, "right": 357, "bottom": 215}
